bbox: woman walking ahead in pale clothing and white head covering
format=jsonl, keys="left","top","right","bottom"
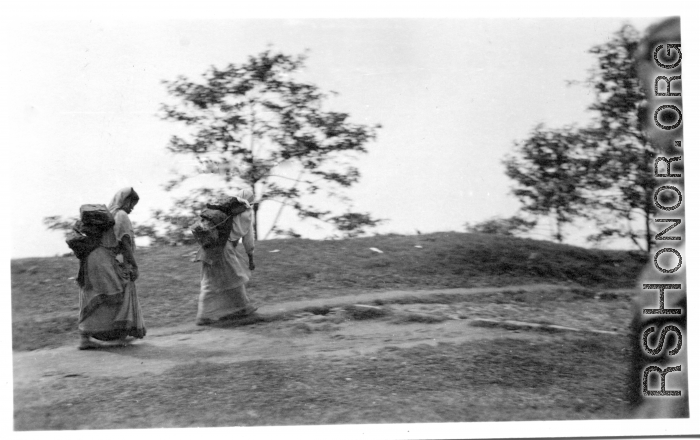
{"left": 195, "top": 189, "right": 257, "bottom": 325}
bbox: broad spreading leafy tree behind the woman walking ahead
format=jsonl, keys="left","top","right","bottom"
{"left": 156, "top": 50, "right": 379, "bottom": 241}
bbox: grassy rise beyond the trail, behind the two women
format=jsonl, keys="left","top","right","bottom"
{"left": 11, "top": 232, "right": 647, "bottom": 350}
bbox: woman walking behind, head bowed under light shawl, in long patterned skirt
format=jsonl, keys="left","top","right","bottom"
{"left": 78, "top": 187, "right": 146, "bottom": 350}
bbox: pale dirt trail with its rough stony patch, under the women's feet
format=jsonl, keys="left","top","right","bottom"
{"left": 13, "top": 286, "right": 628, "bottom": 410}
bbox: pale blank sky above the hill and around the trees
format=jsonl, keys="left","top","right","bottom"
{"left": 0, "top": 8, "right": 680, "bottom": 258}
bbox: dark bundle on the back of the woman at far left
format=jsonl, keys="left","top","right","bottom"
{"left": 66, "top": 204, "right": 114, "bottom": 260}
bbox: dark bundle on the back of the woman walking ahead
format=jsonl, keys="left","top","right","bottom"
{"left": 192, "top": 197, "right": 250, "bottom": 248}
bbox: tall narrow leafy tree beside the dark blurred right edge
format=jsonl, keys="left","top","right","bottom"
{"left": 586, "top": 26, "right": 656, "bottom": 251}
